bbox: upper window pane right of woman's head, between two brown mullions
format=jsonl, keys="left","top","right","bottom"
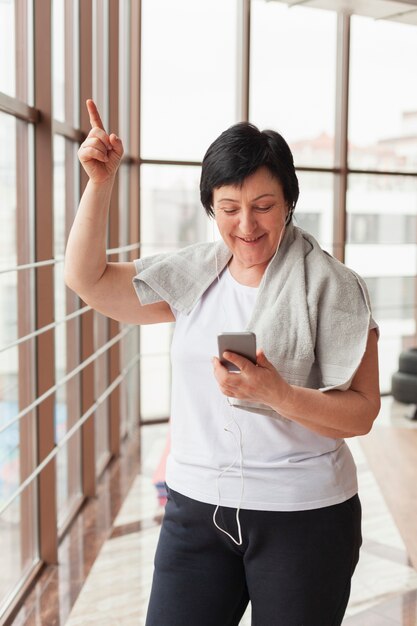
{"left": 249, "top": 0, "right": 336, "bottom": 166}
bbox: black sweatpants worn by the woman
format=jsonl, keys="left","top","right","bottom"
{"left": 146, "top": 489, "right": 362, "bottom": 626}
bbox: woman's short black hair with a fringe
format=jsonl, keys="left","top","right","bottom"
{"left": 200, "top": 122, "right": 299, "bottom": 218}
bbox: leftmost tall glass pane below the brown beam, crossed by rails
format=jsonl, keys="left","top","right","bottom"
{"left": 0, "top": 113, "right": 38, "bottom": 614}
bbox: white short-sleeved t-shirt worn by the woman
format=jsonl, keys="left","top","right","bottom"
{"left": 166, "top": 268, "right": 357, "bottom": 511}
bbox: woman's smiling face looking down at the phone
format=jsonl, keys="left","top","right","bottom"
{"left": 213, "top": 167, "right": 288, "bottom": 283}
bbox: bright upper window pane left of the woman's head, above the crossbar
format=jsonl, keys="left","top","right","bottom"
{"left": 141, "top": 0, "right": 237, "bottom": 160}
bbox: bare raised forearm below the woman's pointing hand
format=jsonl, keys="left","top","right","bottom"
{"left": 65, "top": 178, "right": 114, "bottom": 293}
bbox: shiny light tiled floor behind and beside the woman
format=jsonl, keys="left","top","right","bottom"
{"left": 11, "top": 398, "right": 417, "bottom": 626}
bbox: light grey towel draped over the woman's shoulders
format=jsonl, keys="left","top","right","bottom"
{"left": 133, "top": 224, "right": 372, "bottom": 410}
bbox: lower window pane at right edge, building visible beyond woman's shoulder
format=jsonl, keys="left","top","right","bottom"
{"left": 346, "top": 174, "right": 417, "bottom": 392}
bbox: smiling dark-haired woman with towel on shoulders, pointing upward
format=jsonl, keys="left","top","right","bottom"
{"left": 65, "top": 101, "right": 379, "bottom": 626}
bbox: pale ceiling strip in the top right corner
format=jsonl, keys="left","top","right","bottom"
{"left": 266, "top": 0, "right": 417, "bottom": 25}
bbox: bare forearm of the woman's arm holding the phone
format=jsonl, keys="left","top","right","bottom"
{"left": 271, "top": 385, "right": 379, "bottom": 438}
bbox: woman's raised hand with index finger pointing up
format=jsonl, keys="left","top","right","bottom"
{"left": 78, "top": 100, "right": 123, "bottom": 183}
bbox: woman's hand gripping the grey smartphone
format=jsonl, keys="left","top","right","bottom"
{"left": 213, "top": 350, "right": 291, "bottom": 410}
